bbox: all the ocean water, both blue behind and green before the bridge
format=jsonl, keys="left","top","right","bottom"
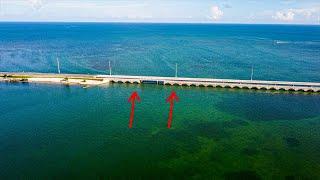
{"left": 0, "top": 23, "right": 320, "bottom": 179}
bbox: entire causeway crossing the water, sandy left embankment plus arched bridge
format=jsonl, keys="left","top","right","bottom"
{"left": 0, "top": 72, "right": 320, "bottom": 92}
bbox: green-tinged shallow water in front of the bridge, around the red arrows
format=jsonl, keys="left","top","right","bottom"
{"left": 0, "top": 84, "right": 320, "bottom": 179}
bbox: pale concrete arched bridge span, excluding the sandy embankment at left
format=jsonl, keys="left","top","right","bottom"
{"left": 96, "top": 75, "right": 320, "bottom": 92}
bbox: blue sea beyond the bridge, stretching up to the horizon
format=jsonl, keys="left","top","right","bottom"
{"left": 0, "top": 23, "right": 320, "bottom": 82}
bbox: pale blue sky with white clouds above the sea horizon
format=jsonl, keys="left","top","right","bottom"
{"left": 0, "top": 0, "right": 320, "bottom": 24}
